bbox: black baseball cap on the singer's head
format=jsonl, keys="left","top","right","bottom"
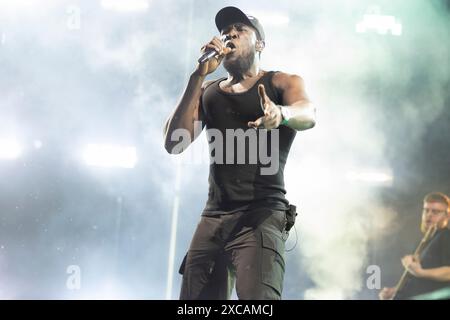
{"left": 216, "top": 7, "right": 265, "bottom": 41}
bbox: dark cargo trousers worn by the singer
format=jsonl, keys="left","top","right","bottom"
{"left": 180, "top": 208, "right": 286, "bottom": 300}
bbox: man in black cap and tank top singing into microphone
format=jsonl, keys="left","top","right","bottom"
{"left": 164, "top": 7, "right": 315, "bottom": 300}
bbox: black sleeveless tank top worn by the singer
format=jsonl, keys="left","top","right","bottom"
{"left": 202, "top": 71, "right": 296, "bottom": 215}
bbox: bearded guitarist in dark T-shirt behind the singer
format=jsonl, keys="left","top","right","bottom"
{"left": 379, "top": 192, "right": 450, "bottom": 300}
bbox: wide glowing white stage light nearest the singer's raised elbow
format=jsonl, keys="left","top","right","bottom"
{"left": 83, "top": 144, "right": 137, "bottom": 169}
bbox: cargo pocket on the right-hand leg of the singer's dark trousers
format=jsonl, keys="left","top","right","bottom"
{"left": 261, "top": 232, "right": 285, "bottom": 299}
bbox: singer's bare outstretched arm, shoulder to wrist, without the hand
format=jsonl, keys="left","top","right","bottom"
{"left": 273, "top": 72, "right": 316, "bottom": 130}
